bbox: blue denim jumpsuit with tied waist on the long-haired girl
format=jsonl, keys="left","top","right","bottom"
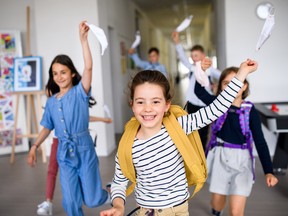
{"left": 40, "top": 82, "right": 108, "bottom": 216}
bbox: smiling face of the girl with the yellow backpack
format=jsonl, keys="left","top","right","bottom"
{"left": 131, "top": 82, "right": 170, "bottom": 136}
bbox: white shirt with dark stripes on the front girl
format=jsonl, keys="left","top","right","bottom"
{"left": 111, "top": 78, "right": 243, "bottom": 209}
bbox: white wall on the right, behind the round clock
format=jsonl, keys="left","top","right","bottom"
{"left": 215, "top": 0, "right": 288, "bottom": 155}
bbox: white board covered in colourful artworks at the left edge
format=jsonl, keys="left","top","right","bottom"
{"left": 0, "top": 30, "right": 28, "bottom": 155}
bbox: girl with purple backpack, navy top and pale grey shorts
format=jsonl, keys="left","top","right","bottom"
{"left": 195, "top": 63, "right": 278, "bottom": 216}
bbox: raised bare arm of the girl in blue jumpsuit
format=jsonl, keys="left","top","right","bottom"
{"left": 79, "top": 21, "right": 93, "bottom": 94}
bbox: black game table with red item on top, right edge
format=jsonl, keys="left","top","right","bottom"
{"left": 255, "top": 102, "right": 288, "bottom": 173}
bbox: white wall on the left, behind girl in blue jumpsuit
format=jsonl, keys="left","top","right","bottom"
{"left": 0, "top": 0, "right": 116, "bottom": 155}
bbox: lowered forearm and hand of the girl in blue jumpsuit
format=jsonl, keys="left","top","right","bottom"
{"left": 27, "top": 127, "right": 51, "bottom": 167}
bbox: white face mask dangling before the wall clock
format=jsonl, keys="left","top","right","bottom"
{"left": 256, "top": 8, "right": 275, "bottom": 51}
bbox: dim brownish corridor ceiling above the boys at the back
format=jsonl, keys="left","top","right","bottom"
{"left": 132, "top": 0, "right": 212, "bottom": 46}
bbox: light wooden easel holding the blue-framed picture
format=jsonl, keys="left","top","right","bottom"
{"left": 10, "top": 6, "right": 46, "bottom": 163}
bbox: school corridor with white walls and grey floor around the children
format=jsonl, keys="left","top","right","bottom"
{"left": 0, "top": 0, "right": 288, "bottom": 216}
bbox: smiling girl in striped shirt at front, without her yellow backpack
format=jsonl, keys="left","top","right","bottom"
{"left": 100, "top": 59, "right": 258, "bottom": 216}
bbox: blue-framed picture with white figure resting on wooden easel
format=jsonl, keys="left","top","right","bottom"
{"left": 14, "top": 56, "right": 42, "bottom": 92}
